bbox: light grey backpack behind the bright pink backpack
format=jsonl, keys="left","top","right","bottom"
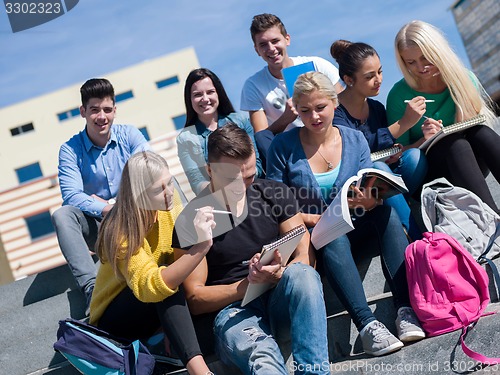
{"left": 421, "top": 178, "right": 500, "bottom": 262}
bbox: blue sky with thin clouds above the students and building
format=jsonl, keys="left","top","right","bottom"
{"left": 0, "top": 0, "right": 470, "bottom": 108}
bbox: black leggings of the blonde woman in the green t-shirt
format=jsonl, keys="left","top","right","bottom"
{"left": 427, "top": 125, "right": 500, "bottom": 212}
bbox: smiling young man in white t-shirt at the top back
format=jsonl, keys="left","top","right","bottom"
{"left": 240, "top": 13, "right": 343, "bottom": 166}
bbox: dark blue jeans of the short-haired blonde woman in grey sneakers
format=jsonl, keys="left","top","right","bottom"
{"left": 320, "top": 206, "right": 410, "bottom": 331}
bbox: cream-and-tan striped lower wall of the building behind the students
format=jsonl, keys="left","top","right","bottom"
{"left": 0, "top": 131, "right": 194, "bottom": 285}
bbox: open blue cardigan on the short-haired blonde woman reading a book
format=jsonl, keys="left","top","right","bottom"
{"left": 266, "top": 126, "right": 372, "bottom": 214}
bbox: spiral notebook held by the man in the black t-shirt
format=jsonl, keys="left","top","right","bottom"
{"left": 241, "top": 225, "right": 307, "bottom": 306}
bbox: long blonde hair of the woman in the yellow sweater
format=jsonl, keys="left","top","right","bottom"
{"left": 96, "top": 151, "right": 173, "bottom": 277}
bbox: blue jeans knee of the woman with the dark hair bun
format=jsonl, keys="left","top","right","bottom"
{"left": 384, "top": 148, "right": 428, "bottom": 195}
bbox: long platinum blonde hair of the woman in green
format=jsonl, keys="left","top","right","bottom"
{"left": 394, "top": 21, "right": 496, "bottom": 123}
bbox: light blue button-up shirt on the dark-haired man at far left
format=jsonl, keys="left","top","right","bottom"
{"left": 58, "top": 125, "right": 151, "bottom": 217}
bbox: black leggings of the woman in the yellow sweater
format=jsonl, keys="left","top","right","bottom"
{"left": 98, "top": 288, "right": 201, "bottom": 365}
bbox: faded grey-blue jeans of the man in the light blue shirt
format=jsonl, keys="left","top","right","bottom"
{"left": 52, "top": 206, "right": 100, "bottom": 296}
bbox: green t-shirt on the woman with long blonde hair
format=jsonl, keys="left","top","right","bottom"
{"left": 386, "top": 79, "right": 456, "bottom": 146}
